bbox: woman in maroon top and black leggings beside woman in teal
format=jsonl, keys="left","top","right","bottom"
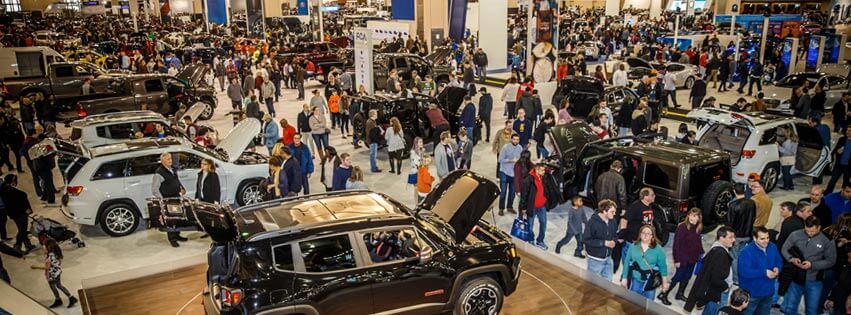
{"left": 658, "top": 208, "right": 703, "bottom": 305}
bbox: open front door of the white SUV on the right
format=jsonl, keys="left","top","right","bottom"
{"left": 792, "top": 122, "right": 831, "bottom": 176}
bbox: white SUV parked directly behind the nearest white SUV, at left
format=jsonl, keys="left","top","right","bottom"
{"left": 71, "top": 103, "right": 206, "bottom": 148}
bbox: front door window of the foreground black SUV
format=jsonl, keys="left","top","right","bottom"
{"left": 363, "top": 229, "right": 421, "bottom": 264}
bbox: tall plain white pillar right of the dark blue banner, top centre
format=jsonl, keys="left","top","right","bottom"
{"left": 478, "top": 0, "right": 508, "bottom": 71}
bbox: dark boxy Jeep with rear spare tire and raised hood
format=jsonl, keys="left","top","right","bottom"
{"left": 550, "top": 122, "right": 734, "bottom": 243}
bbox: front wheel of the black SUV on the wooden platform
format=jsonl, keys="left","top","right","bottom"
{"left": 452, "top": 277, "right": 505, "bottom": 315}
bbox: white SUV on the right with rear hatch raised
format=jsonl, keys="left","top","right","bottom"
{"left": 688, "top": 108, "right": 830, "bottom": 192}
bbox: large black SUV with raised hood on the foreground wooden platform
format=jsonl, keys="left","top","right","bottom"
{"left": 159, "top": 171, "right": 520, "bottom": 315}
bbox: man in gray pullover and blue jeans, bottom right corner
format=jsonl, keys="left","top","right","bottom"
{"left": 780, "top": 216, "right": 836, "bottom": 314}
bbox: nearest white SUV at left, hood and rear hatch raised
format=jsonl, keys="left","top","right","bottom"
{"left": 53, "top": 118, "right": 269, "bottom": 236}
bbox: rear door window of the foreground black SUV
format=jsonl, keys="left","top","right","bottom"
{"left": 298, "top": 234, "right": 357, "bottom": 272}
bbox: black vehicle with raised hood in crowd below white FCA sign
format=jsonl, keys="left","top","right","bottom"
{"left": 347, "top": 86, "right": 468, "bottom": 154}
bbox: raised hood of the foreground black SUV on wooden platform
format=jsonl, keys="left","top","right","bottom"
{"left": 417, "top": 170, "right": 499, "bottom": 244}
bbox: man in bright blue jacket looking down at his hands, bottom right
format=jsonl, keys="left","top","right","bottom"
{"left": 738, "top": 226, "right": 783, "bottom": 315}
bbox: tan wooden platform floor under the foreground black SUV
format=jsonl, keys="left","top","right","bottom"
{"left": 80, "top": 250, "right": 645, "bottom": 315}
